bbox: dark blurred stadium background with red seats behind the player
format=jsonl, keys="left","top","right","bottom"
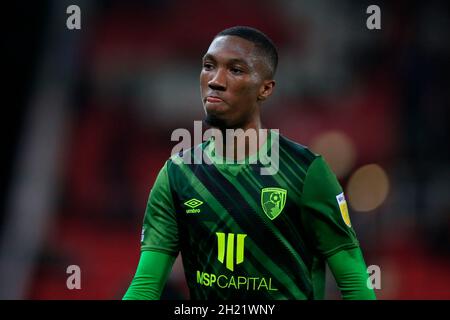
{"left": 0, "top": 0, "right": 450, "bottom": 299}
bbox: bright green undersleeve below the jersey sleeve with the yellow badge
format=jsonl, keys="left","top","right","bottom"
{"left": 327, "top": 248, "right": 376, "bottom": 300}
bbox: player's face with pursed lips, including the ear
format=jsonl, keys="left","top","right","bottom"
{"left": 200, "top": 36, "right": 273, "bottom": 128}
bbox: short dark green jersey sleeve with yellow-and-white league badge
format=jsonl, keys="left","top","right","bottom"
{"left": 300, "top": 156, "right": 359, "bottom": 258}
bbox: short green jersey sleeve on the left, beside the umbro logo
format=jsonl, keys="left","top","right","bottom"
{"left": 141, "top": 162, "right": 179, "bottom": 257}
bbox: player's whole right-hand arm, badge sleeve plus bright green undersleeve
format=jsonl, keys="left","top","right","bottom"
{"left": 302, "top": 156, "right": 375, "bottom": 299}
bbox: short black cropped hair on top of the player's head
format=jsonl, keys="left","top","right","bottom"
{"left": 214, "top": 26, "right": 278, "bottom": 77}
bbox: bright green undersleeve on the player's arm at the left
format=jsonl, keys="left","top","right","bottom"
{"left": 123, "top": 251, "right": 175, "bottom": 300}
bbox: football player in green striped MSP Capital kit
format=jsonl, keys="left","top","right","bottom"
{"left": 123, "top": 26, "right": 375, "bottom": 300}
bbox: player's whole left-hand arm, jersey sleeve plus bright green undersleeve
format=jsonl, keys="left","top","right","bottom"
{"left": 123, "top": 162, "right": 179, "bottom": 300}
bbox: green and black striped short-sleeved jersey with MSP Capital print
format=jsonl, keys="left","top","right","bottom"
{"left": 141, "top": 131, "right": 359, "bottom": 300}
